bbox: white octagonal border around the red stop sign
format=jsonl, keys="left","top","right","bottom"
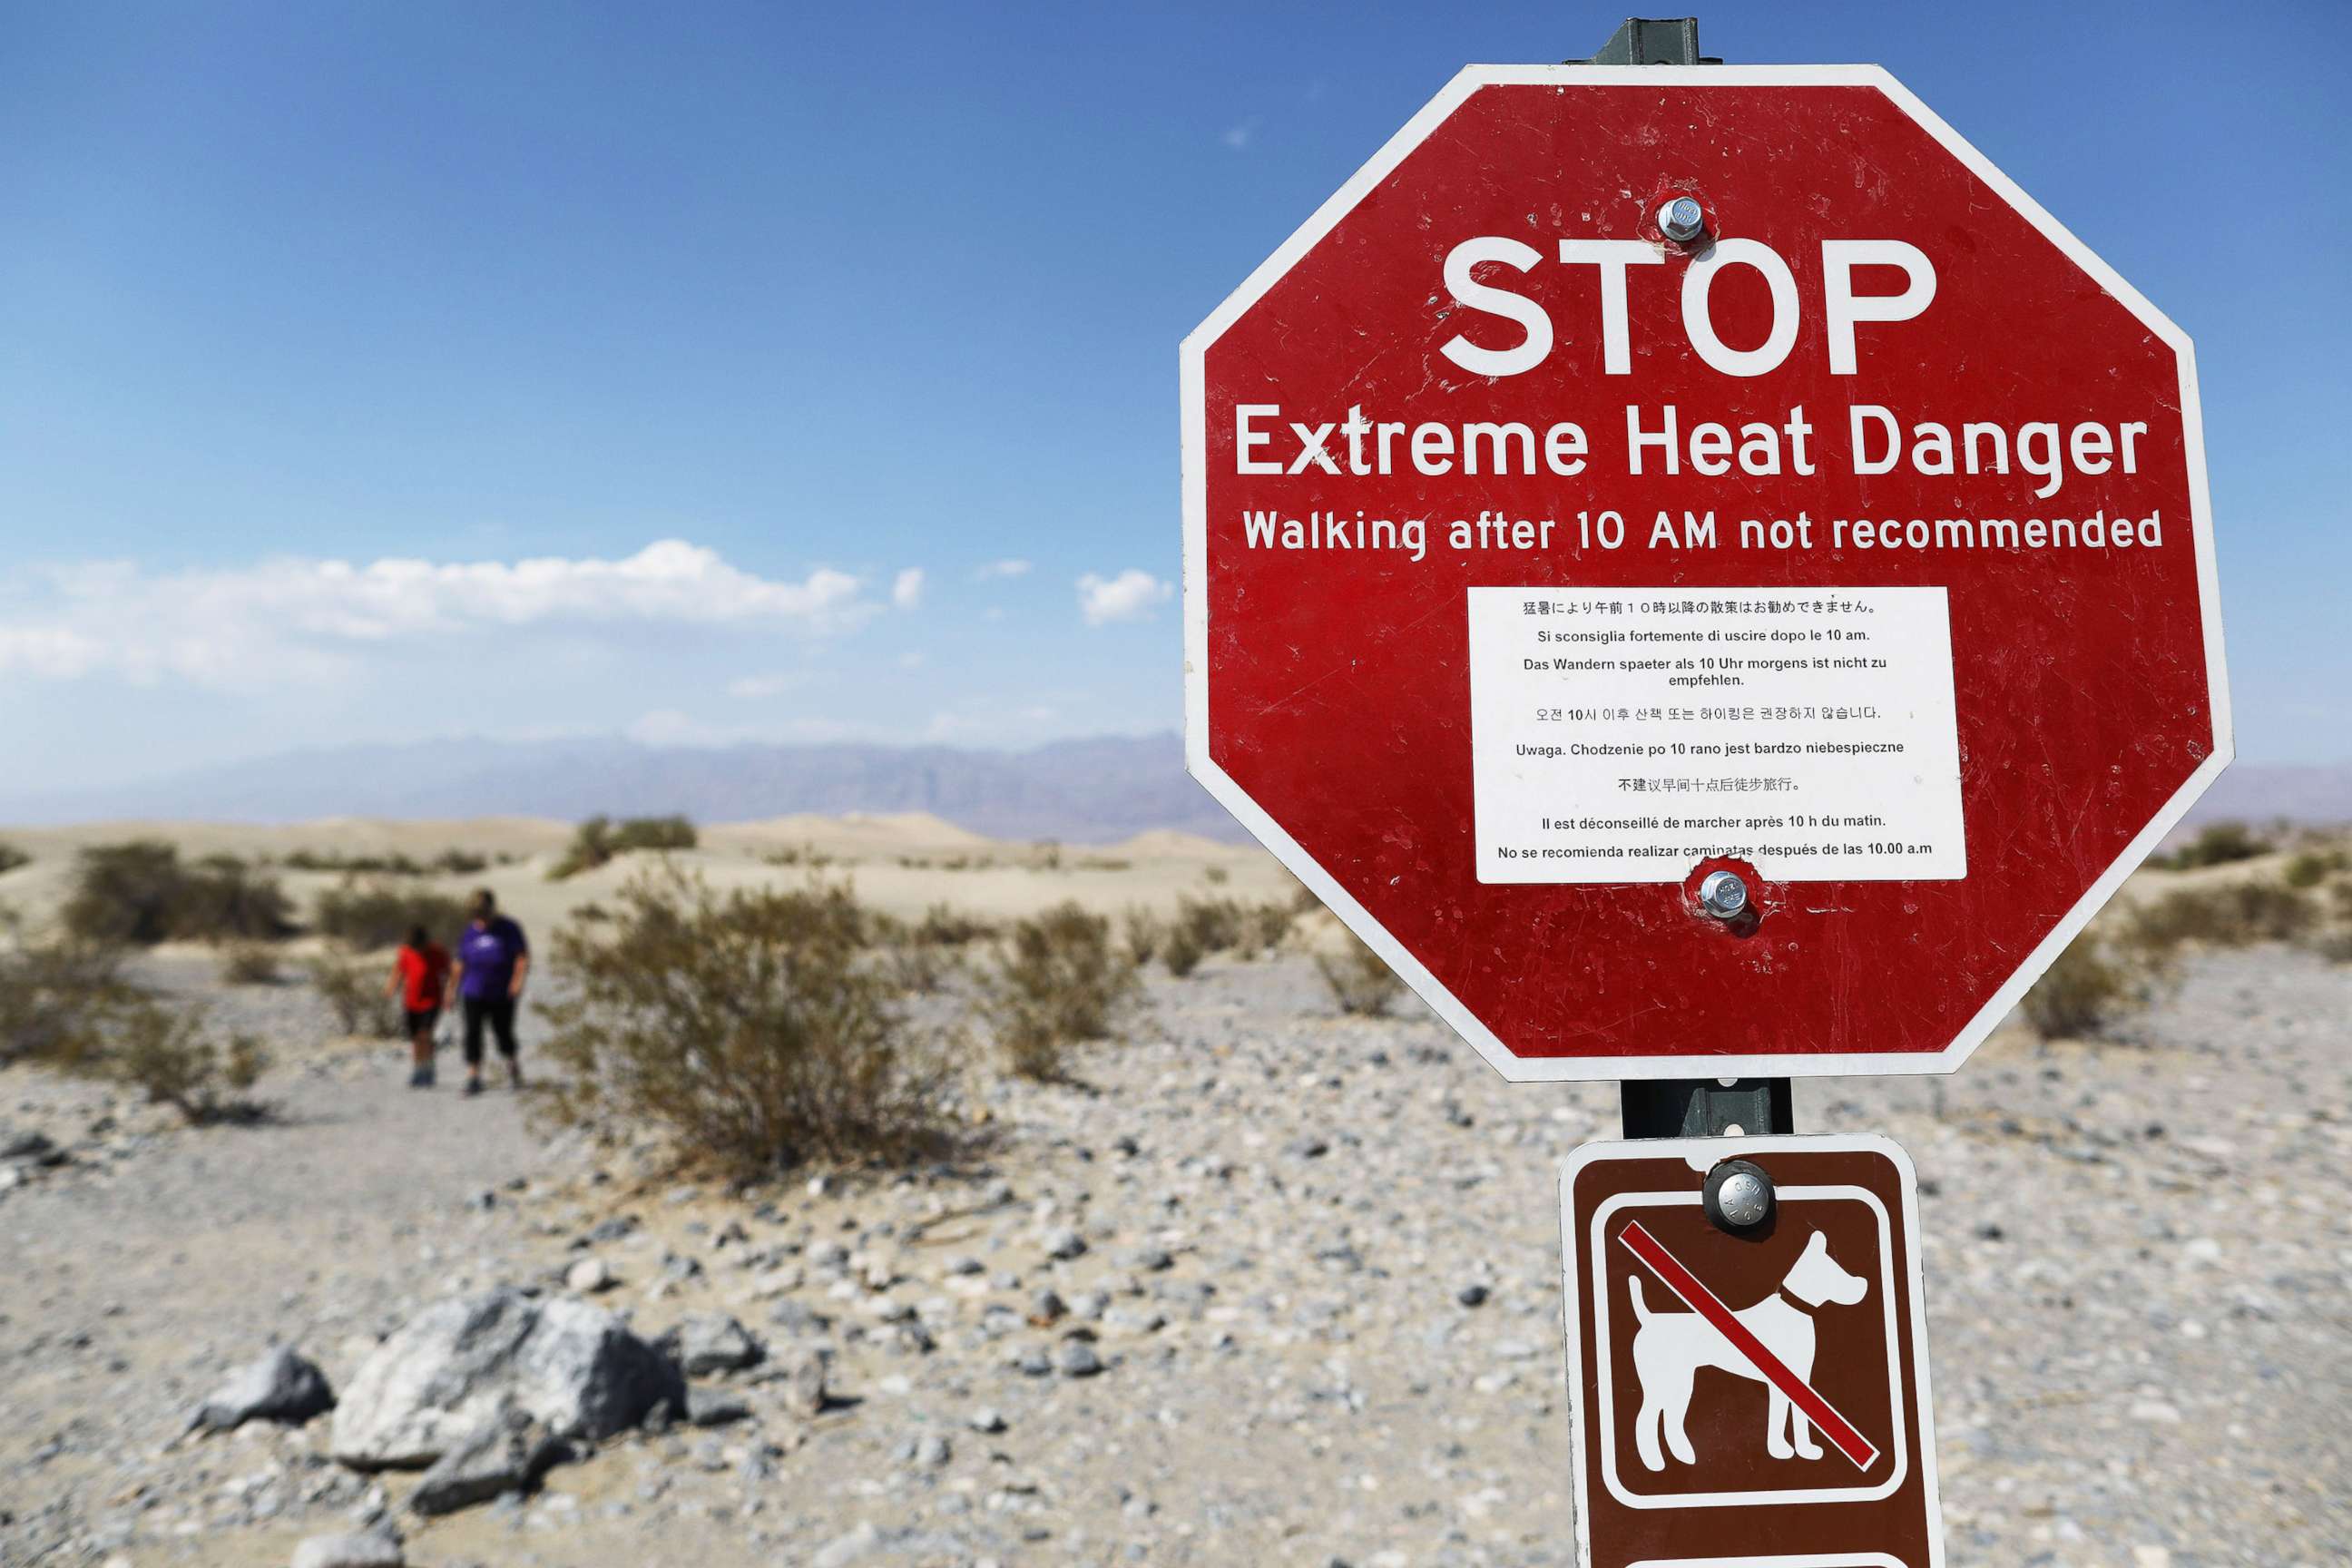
{"left": 1179, "top": 66, "right": 2237, "bottom": 1083}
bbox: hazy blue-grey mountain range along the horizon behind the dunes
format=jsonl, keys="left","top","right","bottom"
{"left": 0, "top": 733, "right": 2352, "bottom": 844}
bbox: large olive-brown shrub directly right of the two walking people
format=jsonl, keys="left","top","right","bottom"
{"left": 545, "top": 870, "right": 943, "bottom": 1178}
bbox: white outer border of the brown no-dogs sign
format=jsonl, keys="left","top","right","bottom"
{"left": 1559, "top": 1133, "right": 1945, "bottom": 1568}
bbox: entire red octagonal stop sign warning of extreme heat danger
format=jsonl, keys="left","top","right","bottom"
{"left": 1183, "top": 66, "right": 2230, "bottom": 1079}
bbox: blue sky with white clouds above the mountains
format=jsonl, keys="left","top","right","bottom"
{"left": 0, "top": 3, "right": 2352, "bottom": 792}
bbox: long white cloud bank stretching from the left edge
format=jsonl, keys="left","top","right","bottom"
{"left": 0, "top": 538, "right": 877, "bottom": 684}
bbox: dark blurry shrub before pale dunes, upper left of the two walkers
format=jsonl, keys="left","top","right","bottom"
{"left": 64, "top": 839, "right": 291, "bottom": 947}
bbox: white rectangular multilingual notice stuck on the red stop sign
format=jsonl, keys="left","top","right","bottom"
{"left": 1470, "top": 588, "right": 1969, "bottom": 882}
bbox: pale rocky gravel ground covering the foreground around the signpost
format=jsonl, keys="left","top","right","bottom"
{"left": 0, "top": 950, "right": 2352, "bottom": 1568}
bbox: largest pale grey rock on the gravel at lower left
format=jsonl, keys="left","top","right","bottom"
{"left": 329, "top": 1289, "right": 687, "bottom": 1469}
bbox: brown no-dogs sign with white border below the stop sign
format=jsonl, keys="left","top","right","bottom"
{"left": 1559, "top": 1138, "right": 1943, "bottom": 1568}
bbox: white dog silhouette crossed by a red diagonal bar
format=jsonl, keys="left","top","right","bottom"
{"left": 1632, "top": 1230, "right": 1870, "bottom": 1469}
